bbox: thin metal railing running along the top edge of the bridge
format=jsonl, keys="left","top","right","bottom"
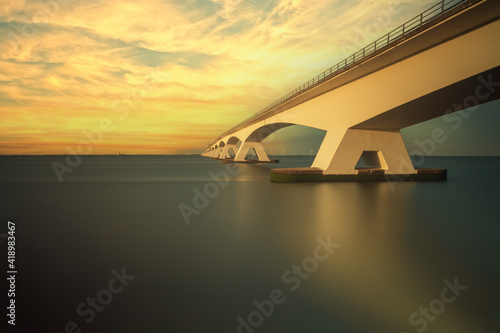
{"left": 215, "top": 0, "right": 478, "bottom": 141}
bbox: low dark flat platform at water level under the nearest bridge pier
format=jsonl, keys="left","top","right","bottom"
{"left": 271, "top": 168, "right": 448, "bottom": 183}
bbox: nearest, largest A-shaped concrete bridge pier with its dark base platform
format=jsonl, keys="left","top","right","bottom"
{"left": 271, "top": 128, "right": 430, "bottom": 182}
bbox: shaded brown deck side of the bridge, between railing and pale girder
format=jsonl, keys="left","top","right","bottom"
{"left": 213, "top": 0, "right": 500, "bottom": 144}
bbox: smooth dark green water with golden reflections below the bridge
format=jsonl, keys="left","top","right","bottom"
{"left": 0, "top": 156, "right": 500, "bottom": 333}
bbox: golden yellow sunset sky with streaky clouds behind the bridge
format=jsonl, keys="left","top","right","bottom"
{"left": 0, "top": 0, "right": 500, "bottom": 155}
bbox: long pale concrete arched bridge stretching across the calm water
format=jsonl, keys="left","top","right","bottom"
{"left": 202, "top": 0, "right": 500, "bottom": 182}
